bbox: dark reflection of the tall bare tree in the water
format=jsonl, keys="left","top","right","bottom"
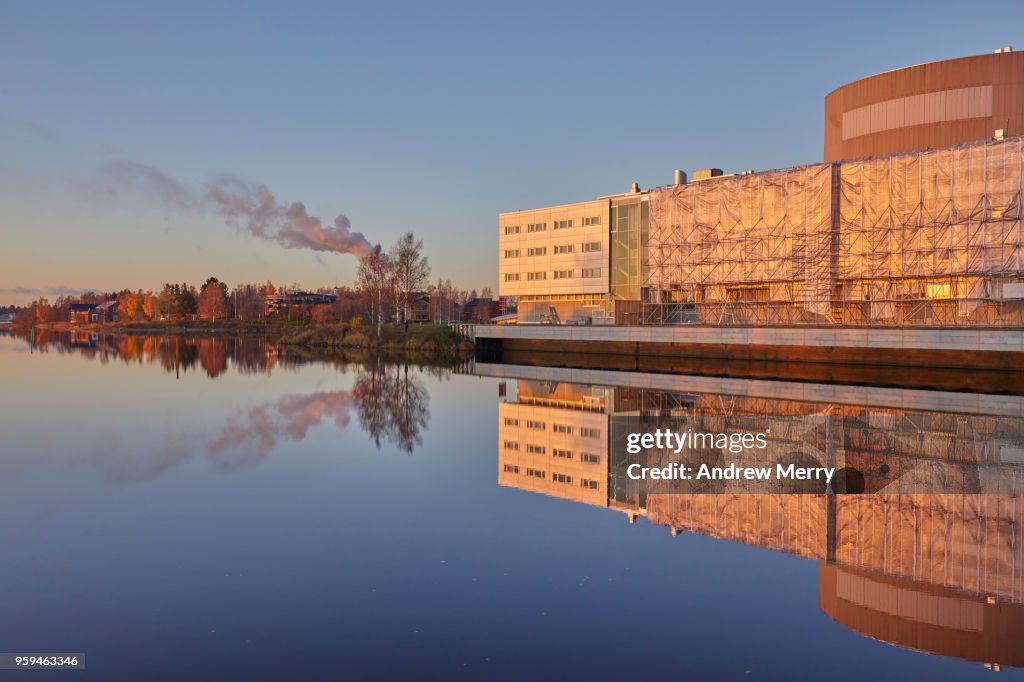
{"left": 352, "top": 364, "right": 430, "bottom": 453}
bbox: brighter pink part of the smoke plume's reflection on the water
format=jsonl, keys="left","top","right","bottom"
{"left": 209, "top": 391, "right": 353, "bottom": 466}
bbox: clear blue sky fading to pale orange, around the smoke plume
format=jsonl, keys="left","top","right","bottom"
{"left": 0, "top": 0, "right": 1024, "bottom": 304}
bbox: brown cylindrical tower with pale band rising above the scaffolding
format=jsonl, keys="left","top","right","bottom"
{"left": 824, "top": 51, "right": 1024, "bottom": 162}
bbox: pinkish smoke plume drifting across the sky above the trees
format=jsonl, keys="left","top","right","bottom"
{"left": 100, "top": 161, "right": 372, "bottom": 258}
